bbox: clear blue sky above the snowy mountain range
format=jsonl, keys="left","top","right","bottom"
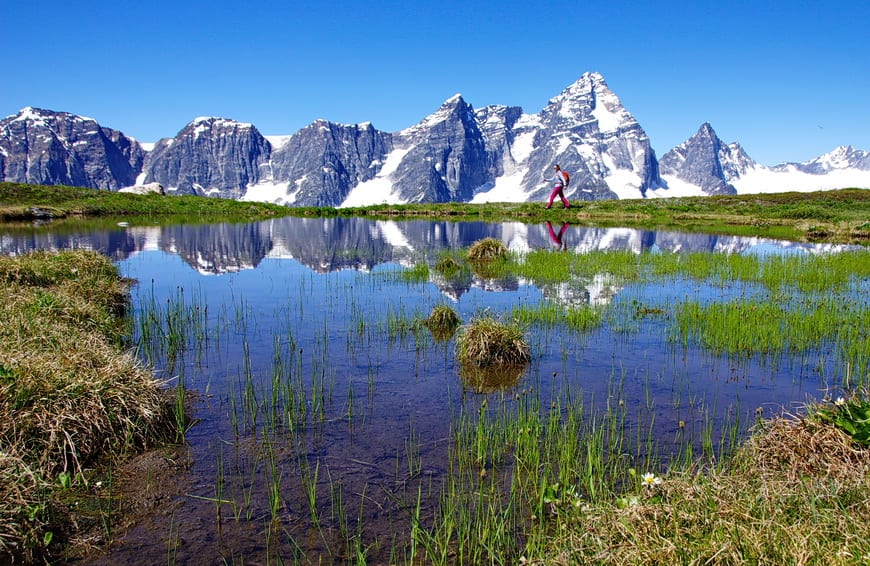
{"left": 0, "top": 0, "right": 870, "bottom": 165}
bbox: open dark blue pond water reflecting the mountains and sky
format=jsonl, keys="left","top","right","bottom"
{"left": 0, "top": 218, "right": 860, "bottom": 564}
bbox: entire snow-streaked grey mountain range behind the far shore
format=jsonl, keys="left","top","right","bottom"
{"left": 0, "top": 73, "right": 870, "bottom": 206}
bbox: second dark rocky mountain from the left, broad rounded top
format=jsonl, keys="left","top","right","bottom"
{"left": 143, "top": 118, "right": 271, "bottom": 198}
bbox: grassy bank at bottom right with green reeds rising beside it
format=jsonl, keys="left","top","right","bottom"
{"left": 408, "top": 390, "right": 870, "bottom": 565}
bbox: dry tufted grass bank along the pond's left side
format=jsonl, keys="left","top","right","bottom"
{"left": 0, "top": 251, "right": 173, "bottom": 560}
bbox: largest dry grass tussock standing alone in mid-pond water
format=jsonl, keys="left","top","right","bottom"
{"left": 456, "top": 317, "right": 532, "bottom": 368}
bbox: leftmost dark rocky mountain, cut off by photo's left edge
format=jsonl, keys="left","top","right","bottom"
{"left": 0, "top": 108, "right": 145, "bottom": 191}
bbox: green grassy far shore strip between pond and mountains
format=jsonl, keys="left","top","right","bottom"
{"left": 0, "top": 183, "right": 870, "bottom": 245}
